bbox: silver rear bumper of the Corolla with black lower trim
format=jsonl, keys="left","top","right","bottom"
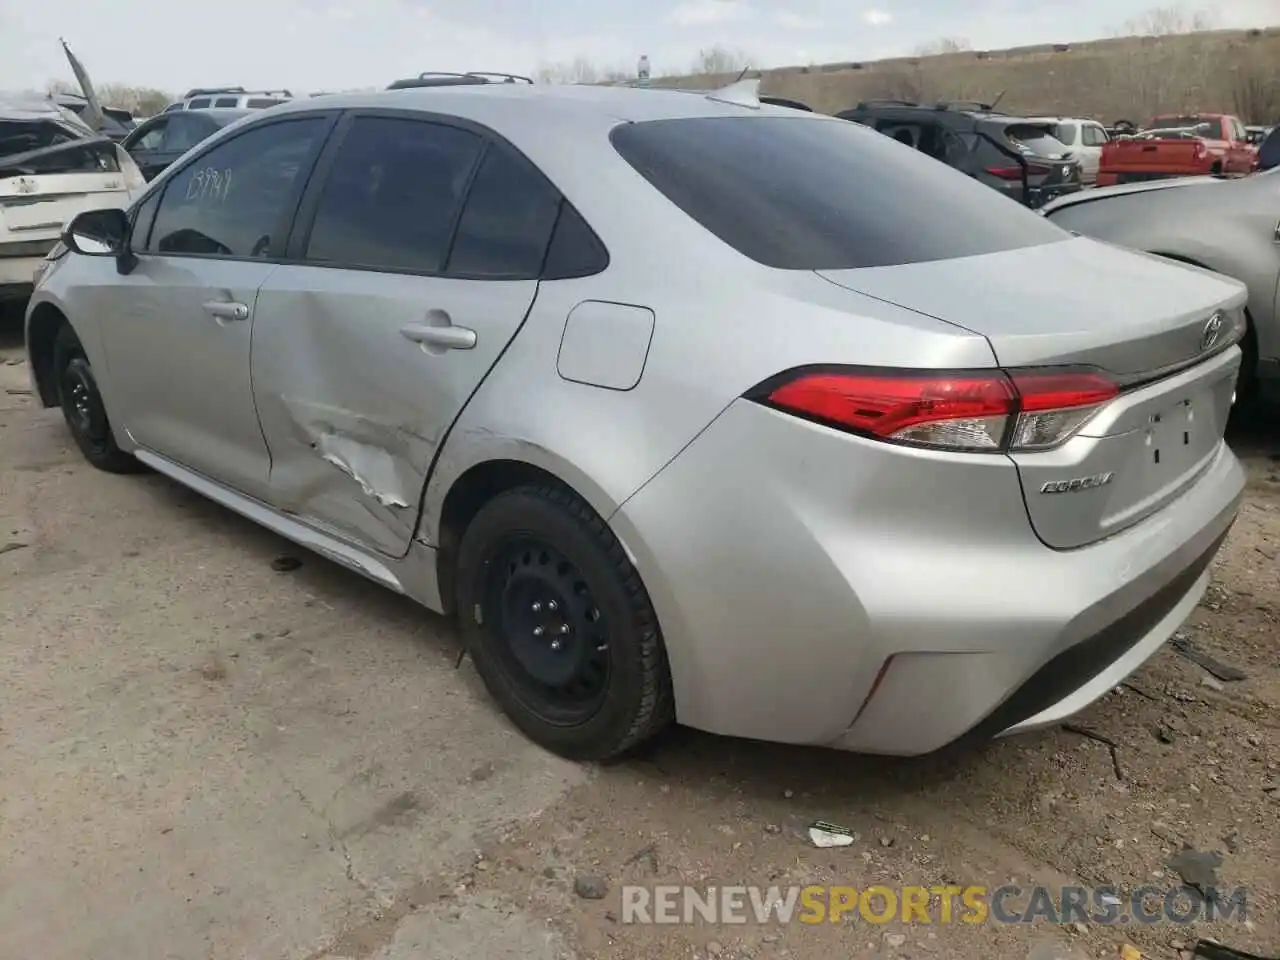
{"left": 611, "top": 401, "right": 1244, "bottom": 755}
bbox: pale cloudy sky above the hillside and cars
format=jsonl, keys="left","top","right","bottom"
{"left": 0, "top": 0, "right": 1280, "bottom": 93}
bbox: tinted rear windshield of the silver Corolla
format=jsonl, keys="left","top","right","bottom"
{"left": 611, "top": 115, "right": 1070, "bottom": 270}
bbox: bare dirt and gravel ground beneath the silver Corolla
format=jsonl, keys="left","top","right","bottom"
{"left": 0, "top": 316, "right": 1280, "bottom": 960}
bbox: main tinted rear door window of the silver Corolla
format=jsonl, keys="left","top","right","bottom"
{"left": 305, "top": 116, "right": 484, "bottom": 273}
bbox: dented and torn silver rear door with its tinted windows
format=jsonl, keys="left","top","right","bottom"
{"left": 252, "top": 111, "right": 559, "bottom": 556}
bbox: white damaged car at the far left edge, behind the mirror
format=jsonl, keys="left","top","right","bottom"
{"left": 0, "top": 96, "right": 146, "bottom": 301}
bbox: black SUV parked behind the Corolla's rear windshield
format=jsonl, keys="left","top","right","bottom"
{"left": 836, "top": 100, "right": 1080, "bottom": 207}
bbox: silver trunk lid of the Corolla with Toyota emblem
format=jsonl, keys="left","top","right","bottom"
{"left": 820, "top": 238, "right": 1247, "bottom": 549}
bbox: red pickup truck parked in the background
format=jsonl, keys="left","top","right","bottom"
{"left": 1098, "top": 114, "right": 1258, "bottom": 187}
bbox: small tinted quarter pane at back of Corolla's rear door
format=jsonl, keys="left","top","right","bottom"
{"left": 448, "top": 143, "right": 559, "bottom": 279}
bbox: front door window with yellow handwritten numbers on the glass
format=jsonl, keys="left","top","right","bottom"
{"left": 148, "top": 116, "right": 328, "bottom": 257}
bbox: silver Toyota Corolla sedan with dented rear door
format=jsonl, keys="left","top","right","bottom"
{"left": 27, "top": 82, "right": 1245, "bottom": 758}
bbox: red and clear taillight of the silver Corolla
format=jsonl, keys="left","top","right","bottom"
{"left": 746, "top": 367, "right": 1120, "bottom": 453}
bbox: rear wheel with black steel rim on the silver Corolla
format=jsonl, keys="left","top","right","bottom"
{"left": 456, "top": 485, "right": 675, "bottom": 760}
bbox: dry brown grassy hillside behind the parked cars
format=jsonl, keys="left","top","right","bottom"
{"left": 654, "top": 27, "right": 1280, "bottom": 123}
